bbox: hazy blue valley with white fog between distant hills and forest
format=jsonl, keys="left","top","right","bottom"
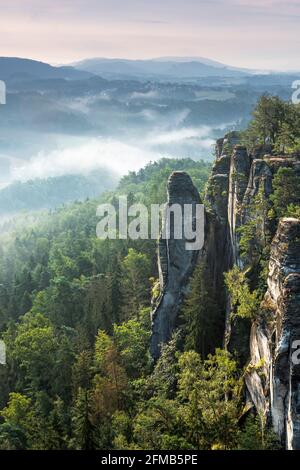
{"left": 0, "top": 74, "right": 246, "bottom": 186}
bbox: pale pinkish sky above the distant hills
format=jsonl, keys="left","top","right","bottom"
{"left": 0, "top": 0, "right": 300, "bottom": 70}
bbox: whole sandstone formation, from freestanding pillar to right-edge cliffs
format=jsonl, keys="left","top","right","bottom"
{"left": 152, "top": 134, "right": 300, "bottom": 449}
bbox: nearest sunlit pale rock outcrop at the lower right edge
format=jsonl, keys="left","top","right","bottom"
{"left": 246, "top": 218, "right": 300, "bottom": 449}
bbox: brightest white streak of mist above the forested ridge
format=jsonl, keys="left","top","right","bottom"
{"left": 10, "top": 126, "right": 223, "bottom": 181}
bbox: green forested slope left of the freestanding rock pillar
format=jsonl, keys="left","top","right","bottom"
{"left": 0, "top": 159, "right": 210, "bottom": 449}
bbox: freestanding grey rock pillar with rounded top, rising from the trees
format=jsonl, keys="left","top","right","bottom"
{"left": 151, "top": 172, "right": 201, "bottom": 359}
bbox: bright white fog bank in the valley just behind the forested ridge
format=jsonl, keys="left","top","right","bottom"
{"left": 0, "top": 117, "right": 232, "bottom": 187}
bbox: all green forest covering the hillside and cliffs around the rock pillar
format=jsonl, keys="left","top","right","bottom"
{"left": 0, "top": 97, "right": 300, "bottom": 450}
